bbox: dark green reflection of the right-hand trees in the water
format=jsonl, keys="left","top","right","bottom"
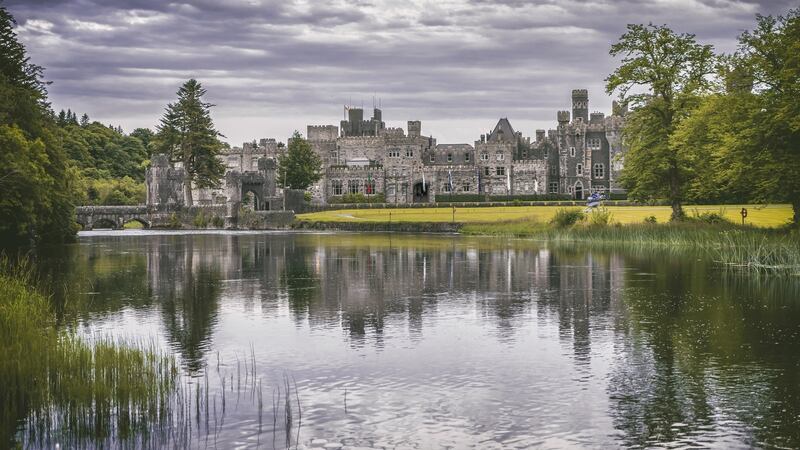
{"left": 609, "top": 257, "right": 800, "bottom": 447}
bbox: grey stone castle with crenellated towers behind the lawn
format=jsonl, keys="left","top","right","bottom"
{"left": 195, "top": 89, "right": 625, "bottom": 204}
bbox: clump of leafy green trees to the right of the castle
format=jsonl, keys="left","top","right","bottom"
{"left": 606, "top": 9, "right": 800, "bottom": 226}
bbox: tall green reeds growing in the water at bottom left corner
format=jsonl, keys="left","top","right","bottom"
{"left": 0, "top": 260, "right": 178, "bottom": 448}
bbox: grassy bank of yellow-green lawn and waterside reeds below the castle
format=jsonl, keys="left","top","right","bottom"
{"left": 298, "top": 205, "right": 800, "bottom": 274}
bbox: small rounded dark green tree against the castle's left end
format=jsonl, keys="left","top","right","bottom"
{"left": 278, "top": 131, "right": 322, "bottom": 189}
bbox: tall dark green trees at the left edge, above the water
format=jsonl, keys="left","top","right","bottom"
{"left": 0, "top": 6, "right": 77, "bottom": 247}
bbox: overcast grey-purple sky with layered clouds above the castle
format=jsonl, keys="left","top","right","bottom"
{"left": 6, "top": 0, "right": 796, "bottom": 145}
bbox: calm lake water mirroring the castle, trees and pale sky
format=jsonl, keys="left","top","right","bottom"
{"left": 39, "top": 231, "right": 800, "bottom": 449}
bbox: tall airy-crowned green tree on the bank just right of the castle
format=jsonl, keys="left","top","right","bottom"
{"left": 606, "top": 24, "right": 716, "bottom": 220}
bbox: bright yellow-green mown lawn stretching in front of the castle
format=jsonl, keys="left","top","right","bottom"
{"left": 297, "top": 205, "right": 792, "bottom": 227}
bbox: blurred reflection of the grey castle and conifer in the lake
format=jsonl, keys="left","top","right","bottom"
{"left": 146, "top": 235, "right": 622, "bottom": 363}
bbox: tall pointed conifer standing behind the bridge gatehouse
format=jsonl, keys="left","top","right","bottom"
{"left": 154, "top": 79, "right": 225, "bottom": 205}
